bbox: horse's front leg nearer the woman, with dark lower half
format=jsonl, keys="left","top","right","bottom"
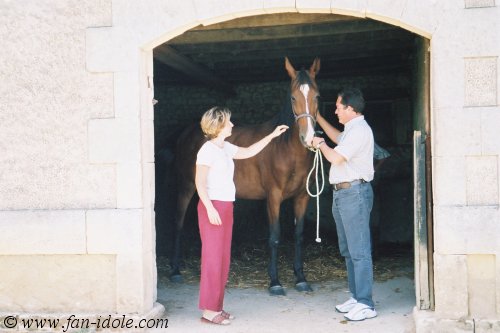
{"left": 267, "top": 195, "right": 285, "bottom": 296}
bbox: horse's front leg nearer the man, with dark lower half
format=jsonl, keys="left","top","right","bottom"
{"left": 293, "top": 193, "right": 312, "bottom": 291}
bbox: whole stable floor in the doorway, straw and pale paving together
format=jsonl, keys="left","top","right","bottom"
{"left": 157, "top": 242, "right": 415, "bottom": 333}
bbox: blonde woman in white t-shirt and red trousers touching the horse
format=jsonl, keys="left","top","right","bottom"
{"left": 195, "top": 107, "right": 288, "bottom": 325}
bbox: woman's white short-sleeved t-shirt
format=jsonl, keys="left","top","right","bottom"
{"left": 196, "top": 141, "right": 238, "bottom": 201}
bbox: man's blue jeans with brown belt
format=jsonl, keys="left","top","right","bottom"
{"left": 332, "top": 183, "right": 374, "bottom": 308}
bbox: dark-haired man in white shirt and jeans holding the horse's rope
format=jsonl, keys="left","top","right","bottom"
{"left": 313, "top": 89, "right": 377, "bottom": 321}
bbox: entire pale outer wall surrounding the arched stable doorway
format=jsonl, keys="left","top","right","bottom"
{"left": 0, "top": 0, "right": 500, "bottom": 332}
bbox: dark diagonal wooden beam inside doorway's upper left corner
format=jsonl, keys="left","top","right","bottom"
{"left": 154, "top": 44, "right": 236, "bottom": 96}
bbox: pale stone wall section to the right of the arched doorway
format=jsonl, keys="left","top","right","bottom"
{"left": 417, "top": 0, "right": 500, "bottom": 332}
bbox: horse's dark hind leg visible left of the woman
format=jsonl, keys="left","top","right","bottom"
{"left": 170, "top": 184, "right": 195, "bottom": 282}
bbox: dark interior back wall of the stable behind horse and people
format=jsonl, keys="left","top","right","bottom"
{"left": 155, "top": 72, "right": 413, "bottom": 254}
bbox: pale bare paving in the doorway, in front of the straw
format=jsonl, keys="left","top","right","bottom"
{"left": 158, "top": 277, "right": 415, "bottom": 333}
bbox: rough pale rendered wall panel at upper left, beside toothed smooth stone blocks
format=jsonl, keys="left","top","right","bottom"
{"left": 0, "top": 1, "right": 116, "bottom": 210}
